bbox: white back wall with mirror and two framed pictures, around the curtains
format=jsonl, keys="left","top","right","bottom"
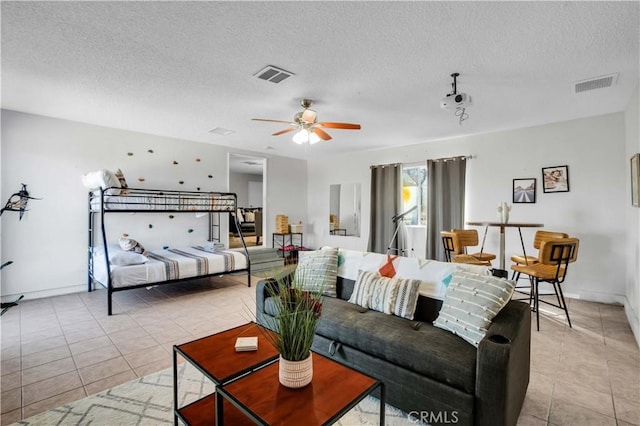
{"left": 309, "top": 113, "right": 637, "bottom": 303}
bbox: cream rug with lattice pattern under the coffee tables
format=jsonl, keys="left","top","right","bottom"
{"left": 15, "top": 363, "right": 417, "bottom": 426}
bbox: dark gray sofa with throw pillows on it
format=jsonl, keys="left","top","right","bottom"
{"left": 256, "top": 264, "right": 531, "bottom": 426}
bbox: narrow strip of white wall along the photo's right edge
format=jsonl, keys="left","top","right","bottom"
{"left": 624, "top": 88, "right": 640, "bottom": 346}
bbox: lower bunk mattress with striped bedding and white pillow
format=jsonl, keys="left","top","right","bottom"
{"left": 94, "top": 246, "right": 247, "bottom": 288}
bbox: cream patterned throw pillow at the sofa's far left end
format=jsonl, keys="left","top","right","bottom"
{"left": 294, "top": 247, "right": 338, "bottom": 297}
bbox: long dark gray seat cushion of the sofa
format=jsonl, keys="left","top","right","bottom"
{"left": 318, "top": 297, "right": 477, "bottom": 392}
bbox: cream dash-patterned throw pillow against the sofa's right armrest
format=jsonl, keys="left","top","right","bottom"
{"left": 433, "top": 271, "right": 515, "bottom": 347}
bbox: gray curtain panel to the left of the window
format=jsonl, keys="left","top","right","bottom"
{"left": 368, "top": 164, "right": 402, "bottom": 253}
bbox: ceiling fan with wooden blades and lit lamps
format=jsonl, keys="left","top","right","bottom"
{"left": 252, "top": 99, "right": 360, "bottom": 144}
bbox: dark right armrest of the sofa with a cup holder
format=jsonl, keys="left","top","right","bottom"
{"left": 475, "top": 301, "right": 531, "bottom": 425}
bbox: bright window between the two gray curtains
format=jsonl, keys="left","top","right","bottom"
{"left": 402, "top": 164, "right": 427, "bottom": 226}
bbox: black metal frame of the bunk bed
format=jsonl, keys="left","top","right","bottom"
{"left": 87, "top": 187, "right": 251, "bottom": 315}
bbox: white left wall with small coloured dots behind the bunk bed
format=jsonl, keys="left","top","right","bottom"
{"left": 0, "top": 110, "right": 306, "bottom": 301}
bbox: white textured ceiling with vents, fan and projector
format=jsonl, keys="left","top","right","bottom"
{"left": 1, "top": 1, "right": 640, "bottom": 158}
